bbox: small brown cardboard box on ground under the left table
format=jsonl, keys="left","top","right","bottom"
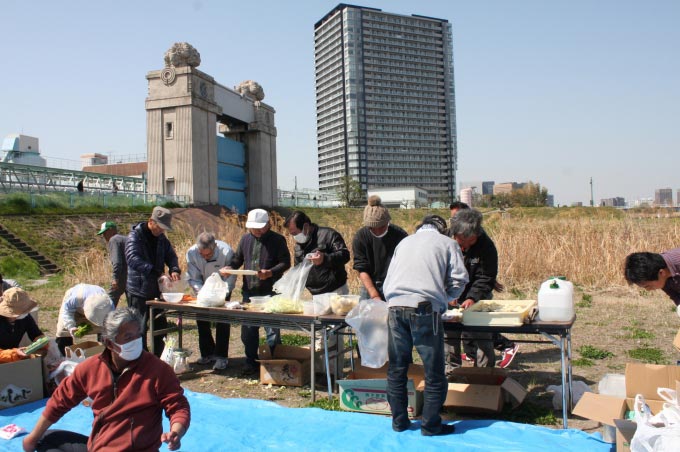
{"left": 258, "top": 345, "right": 316, "bottom": 386}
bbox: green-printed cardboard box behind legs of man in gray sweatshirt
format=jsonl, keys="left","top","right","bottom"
{"left": 338, "top": 364, "right": 425, "bottom": 418}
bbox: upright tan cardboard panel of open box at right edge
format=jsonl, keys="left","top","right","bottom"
{"left": 626, "top": 363, "right": 680, "bottom": 400}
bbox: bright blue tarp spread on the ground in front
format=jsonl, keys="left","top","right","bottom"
{"left": 0, "top": 390, "right": 614, "bottom": 452}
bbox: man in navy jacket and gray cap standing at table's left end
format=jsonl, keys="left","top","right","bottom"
{"left": 125, "top": 206, "right": 181, "bottom": 356}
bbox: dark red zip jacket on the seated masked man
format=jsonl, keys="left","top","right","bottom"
{"left": 43, "top": 349, "right": 191, "bottom": 452}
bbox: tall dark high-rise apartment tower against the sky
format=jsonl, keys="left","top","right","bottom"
{"left": 314, "top": 4, "right": 457, "bottom": 201}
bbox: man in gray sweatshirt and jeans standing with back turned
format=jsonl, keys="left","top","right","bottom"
{"left": 383, "top": 215, "right": 468, "bottom": 436}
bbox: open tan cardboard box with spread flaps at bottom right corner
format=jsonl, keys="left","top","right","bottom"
{"left": 572, "top": 363, "right": 680, "bottom": 451}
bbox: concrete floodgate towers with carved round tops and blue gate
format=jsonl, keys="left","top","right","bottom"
{"left": 146, "top": 43, "right": 277, "bottom": 213}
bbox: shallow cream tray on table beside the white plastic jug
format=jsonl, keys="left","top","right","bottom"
{"left": 463, "top": 300, "right": 537, "bottom": 326}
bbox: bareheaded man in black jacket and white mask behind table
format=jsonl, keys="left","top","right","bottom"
{"left": 284, "top": 210, "right": 349, "bottom": 295}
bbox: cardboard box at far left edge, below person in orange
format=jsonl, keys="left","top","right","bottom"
{"left": 0, "top": 356, "right": 44, "bottom": 410}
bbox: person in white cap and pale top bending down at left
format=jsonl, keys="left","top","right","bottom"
{"left": 56, "top": 284, "right": 115, "bottom": 355}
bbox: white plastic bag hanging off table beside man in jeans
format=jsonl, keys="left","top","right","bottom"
{"left": 345, "top": 300, "right": 388, "bottom": 369}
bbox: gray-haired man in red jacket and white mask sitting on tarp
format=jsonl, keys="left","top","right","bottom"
{"left": 23, "top": 308, "right": 191, "bottom": 452}
